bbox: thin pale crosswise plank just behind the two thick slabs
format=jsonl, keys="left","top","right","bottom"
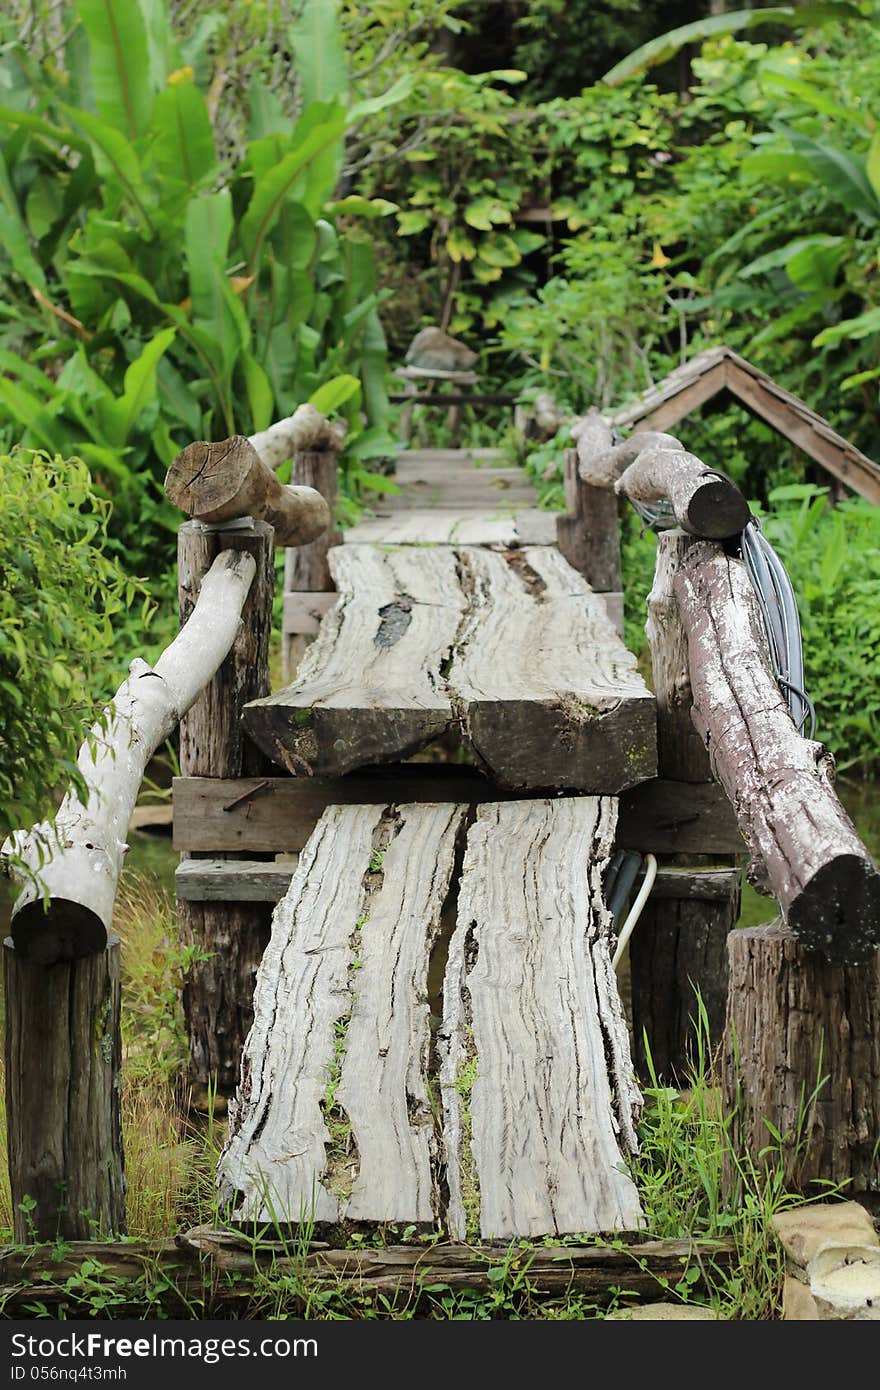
{"left": 345, "top": 500, "right": 556, "bottom": 549}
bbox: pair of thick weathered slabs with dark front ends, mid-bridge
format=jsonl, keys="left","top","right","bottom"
{"left": 245, "top": 546, "right": 655, "bottom": 792}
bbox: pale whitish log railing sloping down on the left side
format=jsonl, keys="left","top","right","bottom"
{"left": 6, "top": 552, "right": 254, "bottom": 965}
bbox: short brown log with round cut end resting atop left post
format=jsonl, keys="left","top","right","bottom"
{"left": 165, "top": 435, "right": 331, "bottom": 545}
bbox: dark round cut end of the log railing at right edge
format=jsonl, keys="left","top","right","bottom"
{"left": 788, "top": 855, "right": 880, "bottom": 965}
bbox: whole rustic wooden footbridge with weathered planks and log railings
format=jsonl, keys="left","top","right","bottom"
{"left": 6, "top": 394, "right": 880, "bottom": 1262}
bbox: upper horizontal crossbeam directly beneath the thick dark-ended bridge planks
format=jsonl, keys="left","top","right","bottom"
{"left": 172, "top": 763, "right": 745, "bottom": 856}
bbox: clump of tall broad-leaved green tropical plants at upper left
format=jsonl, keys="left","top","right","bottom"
{"left": 0, "top": 0, "right": 392, "bottom": 569}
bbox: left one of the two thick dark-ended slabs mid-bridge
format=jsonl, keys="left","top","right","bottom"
{"left": 243, "top": 546, "right": 464, "bottom": 776}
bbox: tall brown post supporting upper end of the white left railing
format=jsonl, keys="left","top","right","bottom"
{"left": 178, "top": 521, "right": 274, "bottom": 1098}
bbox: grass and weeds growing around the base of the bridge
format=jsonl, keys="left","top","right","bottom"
{"left": 0, "top": 866, "right": 837, "bottom": 1321}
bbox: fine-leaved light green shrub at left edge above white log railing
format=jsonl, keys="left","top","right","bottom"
{"left": 0, "top": 449, "right": 143, "bottom": 837}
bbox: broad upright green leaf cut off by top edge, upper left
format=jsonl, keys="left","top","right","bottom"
{"left": 76, "top": 0, "right": 153, "bottom": 140}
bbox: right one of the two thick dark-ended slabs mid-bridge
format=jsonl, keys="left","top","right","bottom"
{"left": 448, "top": 546, "right": 656, "bottom": 792}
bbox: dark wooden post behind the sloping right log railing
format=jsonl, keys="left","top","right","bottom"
{"left": 630, "top": 530, "right": 740, "bottom": 1083}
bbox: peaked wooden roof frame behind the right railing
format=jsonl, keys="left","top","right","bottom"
{"left": 612, "top": 348, "right": 880, "bottom": 505}
